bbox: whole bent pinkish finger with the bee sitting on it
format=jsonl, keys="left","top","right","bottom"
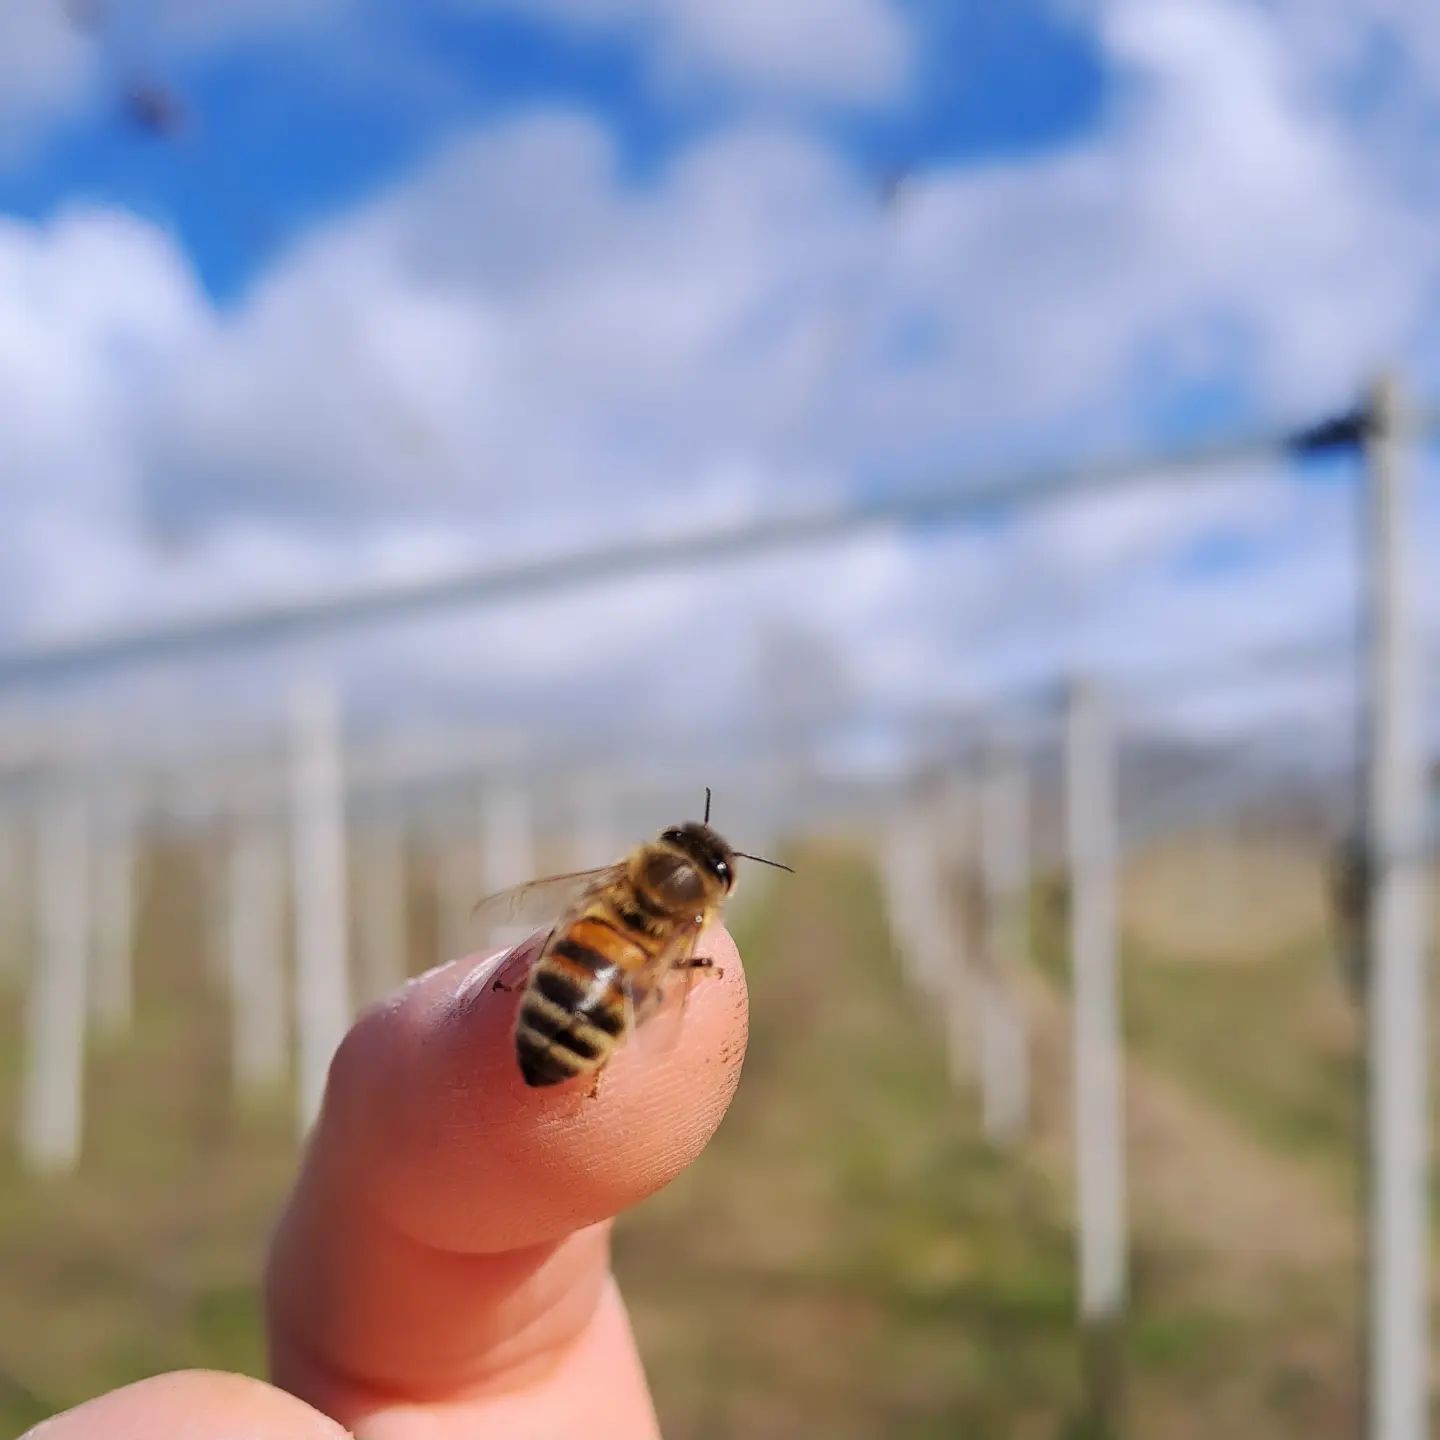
{"left": 268, "top": 929, "right": 747, "bottom": 1437}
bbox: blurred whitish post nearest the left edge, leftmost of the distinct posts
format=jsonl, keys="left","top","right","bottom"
{"left": 20, "top": 775, "right": 91, "bottom": 1172}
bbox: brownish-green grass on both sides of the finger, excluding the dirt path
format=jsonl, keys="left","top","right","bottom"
{"left": 0, "top": 850, "right": 1382, "bottom": 1440}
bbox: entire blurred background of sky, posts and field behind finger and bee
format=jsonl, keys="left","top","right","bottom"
{"left": 0, "top": 0, "right": 1440, "bottom": 1440}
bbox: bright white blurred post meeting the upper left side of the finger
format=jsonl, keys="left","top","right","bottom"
{"left": 291, "top": 685, "right": 350, "bottom": 1129}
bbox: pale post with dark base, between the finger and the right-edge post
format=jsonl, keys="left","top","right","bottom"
{"left": 1066, "top": 685, "right": 1126, "bottom": 1433}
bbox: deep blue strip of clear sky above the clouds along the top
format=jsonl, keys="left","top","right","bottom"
{"left": 0, "top": 0, "right": 1106, "bottom": 304}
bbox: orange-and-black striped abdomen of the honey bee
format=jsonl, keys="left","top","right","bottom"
{"left": 516, "top": 903, "right": 648, "bottom": 1086}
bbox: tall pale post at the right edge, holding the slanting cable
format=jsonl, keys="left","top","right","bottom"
{"left": 1365, "top": 380, "right": 1428, "bottom": 1440}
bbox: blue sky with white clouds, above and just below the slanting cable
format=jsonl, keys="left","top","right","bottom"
{"left": 0, "top": 0, "right": 1440, "bottom": 760}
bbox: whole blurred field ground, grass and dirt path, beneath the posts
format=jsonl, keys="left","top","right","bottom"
{"left": 0, "top": 831, "right": 1428, "bottom": 1437}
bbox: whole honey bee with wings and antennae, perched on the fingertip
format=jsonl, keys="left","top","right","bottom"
{"left": 481, "top": 791, "right": 791, "bottom": 1094}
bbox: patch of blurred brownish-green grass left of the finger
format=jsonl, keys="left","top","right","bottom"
{"left": 0, "top": 857, "right": 294, "bottom": 1436}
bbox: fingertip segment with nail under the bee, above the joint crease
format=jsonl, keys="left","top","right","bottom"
{"left": 321, "top": 927, "right": 749, "bottom": 1254}
